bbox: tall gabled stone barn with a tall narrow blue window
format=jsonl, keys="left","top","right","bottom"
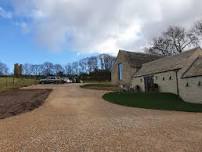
{"left": 111, "top": 50, "right": 160, "bottom": 86}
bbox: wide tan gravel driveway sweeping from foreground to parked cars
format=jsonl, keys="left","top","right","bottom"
{"left": 0, "top": 84, "right": 202, "bottom": 152}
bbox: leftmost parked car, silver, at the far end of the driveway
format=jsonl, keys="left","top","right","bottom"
{"left": 39, "top": 76, "right": 65, "bottom": 84}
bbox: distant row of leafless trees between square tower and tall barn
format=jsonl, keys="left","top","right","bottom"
{"left": 20, "top": 54, "right": 115, "bottom": 76}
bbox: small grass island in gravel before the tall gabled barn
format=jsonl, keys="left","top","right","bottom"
{"left": 81, "top": 83, "right": 119, "bottom": 91}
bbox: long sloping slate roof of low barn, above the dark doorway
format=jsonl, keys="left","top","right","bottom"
{"left": 135, "top": 48, "right": 199, "bottom": 77}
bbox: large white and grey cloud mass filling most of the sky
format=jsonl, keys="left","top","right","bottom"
{"left": 10, "top": 0, "right": 202, "bottom": 53}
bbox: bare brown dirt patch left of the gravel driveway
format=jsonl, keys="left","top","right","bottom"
{"left": 0, "top": 89, "right": 51, "bottom": 119}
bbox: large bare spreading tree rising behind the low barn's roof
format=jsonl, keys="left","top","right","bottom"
{"left": 150, "top": 26, "right": 198, "bottom": 55}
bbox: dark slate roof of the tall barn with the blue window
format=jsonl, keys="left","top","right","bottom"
{"left": 120, "top": 50, "right": 162, "bottom": 68}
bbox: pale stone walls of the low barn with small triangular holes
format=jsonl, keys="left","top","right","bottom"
{"left": 132, "top": 71, "right": 202, "bottom": 104}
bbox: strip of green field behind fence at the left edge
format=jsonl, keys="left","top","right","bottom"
{"left": 0, "top": 77, "right": 38, "bottom": 91}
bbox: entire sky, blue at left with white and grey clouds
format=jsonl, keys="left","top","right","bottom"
{"left": 0, "top": 0, "right": 202, "bottom": 70}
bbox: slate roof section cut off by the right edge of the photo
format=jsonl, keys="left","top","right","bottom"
{"left": 183, "top": 56, "right": 202, "bottom": 78}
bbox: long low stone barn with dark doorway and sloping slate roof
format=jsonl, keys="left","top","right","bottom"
{"left": 132, "top": 48, "right": 202, "bottom": 103}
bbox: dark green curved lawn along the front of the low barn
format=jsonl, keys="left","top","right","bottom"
{"left": 103, "top": 92, "right": 202, "bottom": 112}
